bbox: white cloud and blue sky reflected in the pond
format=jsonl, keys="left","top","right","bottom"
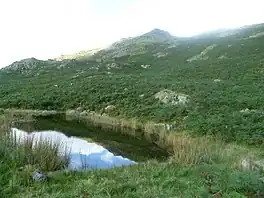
{"left": 12, "top": 128, "right": 136, "bottom": 170}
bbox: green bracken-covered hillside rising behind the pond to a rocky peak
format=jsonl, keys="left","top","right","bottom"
{"left": 0, "top": 24, "right": 264, "bottom": 144}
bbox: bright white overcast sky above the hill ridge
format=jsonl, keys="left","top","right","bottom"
{"left": 0, "top": 0, "right": 264, "bottom": 68}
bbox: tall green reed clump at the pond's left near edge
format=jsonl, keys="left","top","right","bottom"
{"left": 0, "top": 129, "right": 69, "bottom": 171}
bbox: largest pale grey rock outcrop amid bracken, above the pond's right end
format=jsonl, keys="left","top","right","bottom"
{"left": 155, "top": 89, "right": 188, "bottom": 105}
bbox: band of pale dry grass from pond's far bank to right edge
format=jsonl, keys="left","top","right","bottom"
{"left": 66, "top": 111, "right": 261, "bottom": 167}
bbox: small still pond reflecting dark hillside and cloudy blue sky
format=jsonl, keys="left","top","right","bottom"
{"left": 12, "top": 116, "right": 169, "bottom": 168}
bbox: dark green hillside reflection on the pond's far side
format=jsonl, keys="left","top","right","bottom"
{"left": 9, "top": 110, "right": 169, "bottom": 162}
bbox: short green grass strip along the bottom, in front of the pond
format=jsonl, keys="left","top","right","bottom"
{"left": 0, "top": 162, "right": 264, "bottom": 198}
